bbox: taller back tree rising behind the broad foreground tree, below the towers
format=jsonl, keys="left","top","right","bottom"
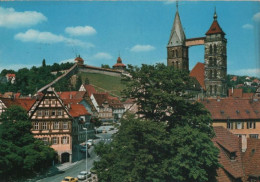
{"left": 123, "top": 64, "right": 213, "bottom": 135}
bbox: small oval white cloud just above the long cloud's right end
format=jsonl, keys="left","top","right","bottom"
{"left": 65, "top": 26, "right": 97, "bottom": 36}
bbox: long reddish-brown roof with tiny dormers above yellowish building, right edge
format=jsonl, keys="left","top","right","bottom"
{"left": 200, "top": 98, "right": 260, "bottom": 120}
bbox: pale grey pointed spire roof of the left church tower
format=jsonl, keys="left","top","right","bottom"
{"left": 168, "top": 11, "right": 186, "bottom": 47}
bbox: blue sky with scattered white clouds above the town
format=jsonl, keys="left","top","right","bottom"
{"left": 0, "top": 1, "right": 260, "bottom": 77}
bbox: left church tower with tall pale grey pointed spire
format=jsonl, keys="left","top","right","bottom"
{"left": 167, "top": 4, "right": 189, "bottom": 71}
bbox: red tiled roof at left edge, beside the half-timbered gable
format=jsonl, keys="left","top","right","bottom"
{"left": 1, "top": 98, "right": 36, "bottom": 111}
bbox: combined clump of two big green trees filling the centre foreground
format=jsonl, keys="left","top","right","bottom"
{"left": 94, "top": 64, "right": 219, "bottom": 182}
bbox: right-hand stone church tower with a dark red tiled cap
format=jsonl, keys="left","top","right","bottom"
{"left": 204, "top": 10, "right": 227, "bottom": 97}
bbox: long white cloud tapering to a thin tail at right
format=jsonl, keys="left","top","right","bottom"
{"left": 14, "top": 29, "right": 94, "bottom": 47}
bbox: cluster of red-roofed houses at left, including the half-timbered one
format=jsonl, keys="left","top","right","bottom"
{"left": 0, "top": 85, "right": 129, "bottom": 163}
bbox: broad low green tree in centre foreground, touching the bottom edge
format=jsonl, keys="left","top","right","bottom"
{"left": 94, "top": 115, "right": 219, "bottom": 182}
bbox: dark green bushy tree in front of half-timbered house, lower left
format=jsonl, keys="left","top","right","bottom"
{"left": 0, "top": 106, "right": 56, "bottom": 181}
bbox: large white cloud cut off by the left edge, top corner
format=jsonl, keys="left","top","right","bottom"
{"left": 0, "top": 7, "right": 47, "bottom": 28}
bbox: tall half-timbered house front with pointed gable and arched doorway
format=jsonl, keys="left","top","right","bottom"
{"left": 29, "top": 87, "right": 75, "bottom": 163}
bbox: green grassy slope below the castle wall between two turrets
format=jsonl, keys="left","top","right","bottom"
{"left": 79, "top": 73, "right": 125, "bottom": 96}
